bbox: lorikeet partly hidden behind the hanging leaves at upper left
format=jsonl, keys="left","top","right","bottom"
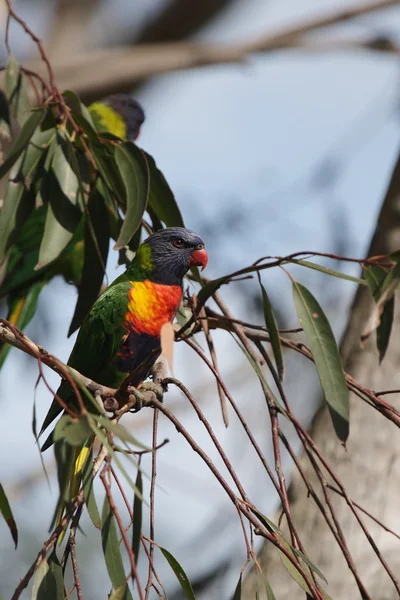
{"left": 0, "top": 94, "right": 144, "bottom": 368}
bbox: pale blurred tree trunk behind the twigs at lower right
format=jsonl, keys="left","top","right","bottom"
{"left": 242, "top": 150, "right": 400, "bottom": 600}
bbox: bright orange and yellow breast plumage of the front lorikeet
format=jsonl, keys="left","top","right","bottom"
{"left": 124, "top": 281, "right": 182, "bottom": 337}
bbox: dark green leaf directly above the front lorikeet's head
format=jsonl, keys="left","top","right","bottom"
{"left": 144, "top": 152, "right": 185, "bottom": 227}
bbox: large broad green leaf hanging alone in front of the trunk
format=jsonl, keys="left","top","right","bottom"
{"left": 293, "top": 281, "right": 350, "bottom": 442}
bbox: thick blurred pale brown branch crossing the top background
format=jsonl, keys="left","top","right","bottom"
{"left": 13, "top": 0, "right": 399, "bottom": 102}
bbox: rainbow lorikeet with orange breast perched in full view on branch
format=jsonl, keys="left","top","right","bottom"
{"left": 40, "top": 227, "right": 208, "bottom": 518}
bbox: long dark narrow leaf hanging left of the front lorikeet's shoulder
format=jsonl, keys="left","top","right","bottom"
{"left": 68, "top": 192, "right": 110, "bottom": 336}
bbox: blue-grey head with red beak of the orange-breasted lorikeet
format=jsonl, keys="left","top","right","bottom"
{"left": 137, "top": 227, "right": 208, "bottom": 285}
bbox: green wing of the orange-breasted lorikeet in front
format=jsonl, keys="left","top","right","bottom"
{"left": 39, "top": 281, "right": 132, "bottom": 438}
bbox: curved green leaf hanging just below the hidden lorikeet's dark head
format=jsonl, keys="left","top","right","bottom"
{"left": 114, "top": 142, "right": 149, "bottom": 250}
